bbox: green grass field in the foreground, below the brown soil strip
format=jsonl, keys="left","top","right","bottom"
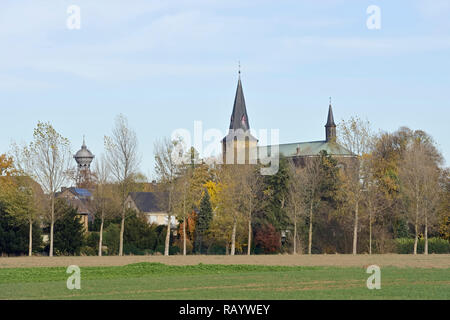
{"left": 0, "top": 263, "right": 450, "bottom": 300}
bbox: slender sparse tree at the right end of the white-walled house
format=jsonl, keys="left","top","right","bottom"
{"left": 154, "top": 138, "right": 183, "bottom": 256}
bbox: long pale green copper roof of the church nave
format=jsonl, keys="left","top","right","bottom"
{"left": 258, "top": 141, "right": 354, "bottom": 157}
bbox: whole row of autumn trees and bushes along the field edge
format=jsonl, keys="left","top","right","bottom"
{"left": 0, "top": 115, "right": 450, "bottom": 256}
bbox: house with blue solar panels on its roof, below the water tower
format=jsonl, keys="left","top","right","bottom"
{"left": 56, "top": 187, "right": 94, "bottom": 231}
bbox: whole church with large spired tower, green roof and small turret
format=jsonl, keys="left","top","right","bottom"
{"left": 222, "top": 72, "right": 355, "bottom": 166}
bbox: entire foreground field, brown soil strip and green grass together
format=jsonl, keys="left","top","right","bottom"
{"left": 0, "top": 255, "right": 450, "bottom": 300}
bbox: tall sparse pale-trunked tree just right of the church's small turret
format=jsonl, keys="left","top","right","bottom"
{"left": 339, "top": 117, "right": 372, "bottom": 254}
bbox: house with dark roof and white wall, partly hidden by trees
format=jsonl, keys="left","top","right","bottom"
{"left": 125, "top": 192, "right": 178, "bottom": 229}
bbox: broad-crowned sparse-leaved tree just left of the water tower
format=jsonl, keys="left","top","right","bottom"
{"left": 12, "top": 122, "right": 72, "bottom": 257}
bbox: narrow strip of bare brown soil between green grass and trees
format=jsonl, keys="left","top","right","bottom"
{"left": 0, "top": 254, "right": 450, "bottom": 268}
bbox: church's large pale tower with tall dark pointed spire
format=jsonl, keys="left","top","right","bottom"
{"left": 222, "top": 70, "right": 258, "bottom": 164}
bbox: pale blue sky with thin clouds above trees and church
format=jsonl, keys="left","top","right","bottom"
{"left": 0, "top": 0, "right": 450, "bottom": 179}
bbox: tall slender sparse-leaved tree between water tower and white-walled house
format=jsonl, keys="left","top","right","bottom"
{"left": 105, "top": 114, "right": 140, "bottom": 256}
